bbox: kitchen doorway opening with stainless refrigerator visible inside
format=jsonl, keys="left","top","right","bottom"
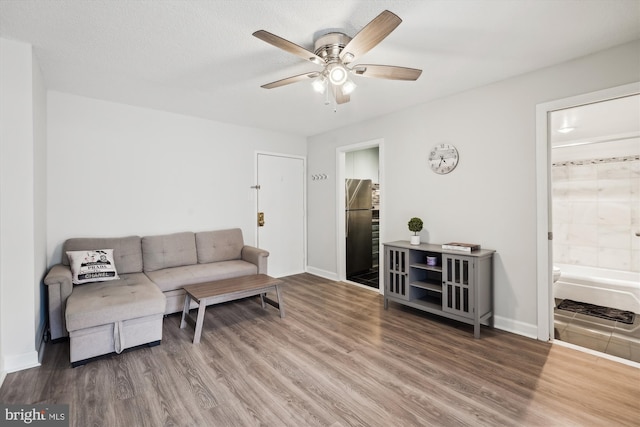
{"left": 337, "top": 141, "right": 383, "bottom": 292}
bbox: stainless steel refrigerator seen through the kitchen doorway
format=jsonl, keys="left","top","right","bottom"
{"left": 345, "top": 179, "right": 373, "bottom": 277}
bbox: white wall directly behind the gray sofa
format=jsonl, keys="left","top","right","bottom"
{"left": 47, "top": 92, "right": 306, "bottom": 264}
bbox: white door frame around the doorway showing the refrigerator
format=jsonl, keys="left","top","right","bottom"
{"left": 336, "top": 139, "right": 386, "bottom": 294}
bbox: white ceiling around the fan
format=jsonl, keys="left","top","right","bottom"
{"left": 0, "top": 0, "right": 640, "bottom": 135}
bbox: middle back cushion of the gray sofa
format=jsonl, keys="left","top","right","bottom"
{"left": 142, "top": 231, "right": 198, "bottom": 272}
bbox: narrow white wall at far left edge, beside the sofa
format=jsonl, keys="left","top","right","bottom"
{"left": 0, "top": 39, "right": 45, "bottom": 380}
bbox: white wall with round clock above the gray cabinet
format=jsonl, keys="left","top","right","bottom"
{"left": 308, "top": 42, "right": 640, "bottom": 337}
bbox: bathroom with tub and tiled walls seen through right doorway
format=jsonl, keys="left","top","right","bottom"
{"left": 548, "top": 94, "right": 640, "bottom": 363}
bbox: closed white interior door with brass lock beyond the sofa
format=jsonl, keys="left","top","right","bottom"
{"left": 256, "top": 153, "right": 306, "bottom": 277}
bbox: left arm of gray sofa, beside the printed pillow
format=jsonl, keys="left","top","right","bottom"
{"left": 44, "top": 264, "right": 73, "bottom": 340}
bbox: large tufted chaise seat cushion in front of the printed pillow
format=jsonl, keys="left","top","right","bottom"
{"left": 65, "top": 273, "right": 166, "bottom": 332}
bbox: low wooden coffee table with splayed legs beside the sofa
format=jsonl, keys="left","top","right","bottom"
{"left": 180, "top": 274, "right": 284, "bottom": 344}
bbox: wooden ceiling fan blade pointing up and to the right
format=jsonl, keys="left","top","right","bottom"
{"left": 340, "top": 10, "right": 402, "bottom": 64}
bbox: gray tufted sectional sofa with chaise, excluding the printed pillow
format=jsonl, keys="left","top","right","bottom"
{"left": 44, "top": 228, "right": 269, "bottom": 366}
